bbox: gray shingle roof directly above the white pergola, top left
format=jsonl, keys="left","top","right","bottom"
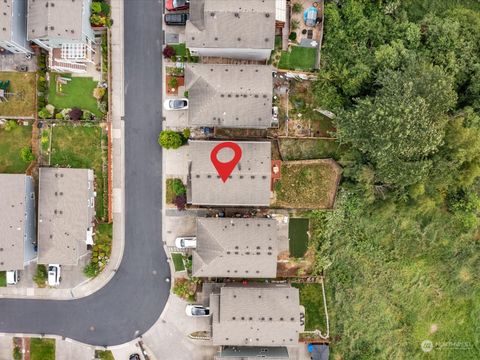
{"left": 27, "top": 0, "right": 83, "bottom": 40}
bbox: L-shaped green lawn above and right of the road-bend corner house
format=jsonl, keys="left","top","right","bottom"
{"left": 50, "top": 125, "right": 107, "bottom": 220}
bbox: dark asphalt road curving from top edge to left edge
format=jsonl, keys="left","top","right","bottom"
{"left": 0, "top": 0, "right": 170, "bottom": 346}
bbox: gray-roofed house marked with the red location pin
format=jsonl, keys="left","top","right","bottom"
{"left": 187, "top": 141, "right": 271, "bottom": 206}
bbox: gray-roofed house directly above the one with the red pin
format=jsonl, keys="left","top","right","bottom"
{"left": 185, "top": 64, "right": 273, "bottom": 129}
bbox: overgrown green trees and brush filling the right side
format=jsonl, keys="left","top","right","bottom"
{"left": 308, "top": 0, "right": 480, "bottom": 359}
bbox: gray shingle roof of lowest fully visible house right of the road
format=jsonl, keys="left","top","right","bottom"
{"left": 210, "top": 285, "right": 304, "bottom": 346}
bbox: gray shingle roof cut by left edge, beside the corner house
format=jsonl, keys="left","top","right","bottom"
{"left": 0, "top": 174, "right": 26, "bottom": 271}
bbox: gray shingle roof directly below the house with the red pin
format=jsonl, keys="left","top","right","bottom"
{"left": 193, "top": 218, "right": 278, "bottom": 278}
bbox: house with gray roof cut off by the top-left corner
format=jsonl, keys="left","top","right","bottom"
{"left": 0, "top": 0, "right": 32, "bottom": 54}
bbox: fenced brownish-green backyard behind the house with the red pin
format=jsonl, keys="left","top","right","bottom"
{"left": 274, "top": 160, "right": 341, "bottom": 209}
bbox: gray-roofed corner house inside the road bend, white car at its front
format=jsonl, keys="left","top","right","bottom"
{"left": 38, "top": 168, "right": 96, "bottom": 265}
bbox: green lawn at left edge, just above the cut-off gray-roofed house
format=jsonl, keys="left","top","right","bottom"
{"left": 0, "top": 125, "right": 32, "bottom": 174}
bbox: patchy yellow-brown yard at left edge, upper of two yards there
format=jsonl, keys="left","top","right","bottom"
{"left": 0, "top": 72, "right": 36, "bottom": 117}
